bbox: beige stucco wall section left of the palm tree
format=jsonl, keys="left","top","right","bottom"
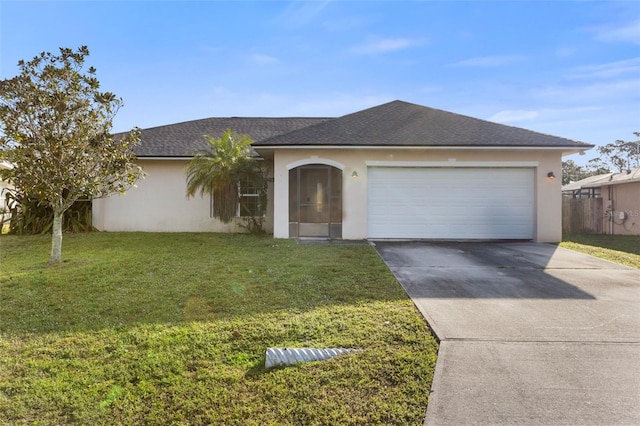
{"left": 93, "top": 160, "right": 272, "bottom": 232}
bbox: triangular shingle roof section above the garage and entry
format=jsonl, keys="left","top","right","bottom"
{"left": 253, "top": 101, "right": 593, "bottom": 149}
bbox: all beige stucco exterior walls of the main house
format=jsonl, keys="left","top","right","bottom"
{"left": 93, "top": 147, "right": 562, "bottom": 242}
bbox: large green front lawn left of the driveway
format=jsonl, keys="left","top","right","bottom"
{"left": 0, "top": 233, "right": 437, "bottom": 425}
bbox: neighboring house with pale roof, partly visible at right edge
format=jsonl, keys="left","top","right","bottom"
{"left": 562, "top": 167, "right": 640, "bottom": 235}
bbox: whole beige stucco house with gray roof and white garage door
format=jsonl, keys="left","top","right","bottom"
{"left": 93, "top": 101, "right": 593, "bottom": 242}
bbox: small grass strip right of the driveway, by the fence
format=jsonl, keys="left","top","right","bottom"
{"left": 558, "top": 234, "right": 640, "bottom": 269}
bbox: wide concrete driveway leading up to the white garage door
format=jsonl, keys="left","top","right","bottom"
{"left": 376, "top": 242, "right": 640, "bottom": 425}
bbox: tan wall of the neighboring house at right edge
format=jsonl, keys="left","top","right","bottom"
{"left": 601, "top": 182, "right": 640, "bottom": 235}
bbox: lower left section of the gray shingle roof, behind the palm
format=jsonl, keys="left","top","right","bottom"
{"left": 135, "top": 117, "right": 327, "bottom": 158}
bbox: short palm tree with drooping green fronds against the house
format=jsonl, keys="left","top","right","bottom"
{"left": 187, "top": 130, "right": 266, "bottom": 223}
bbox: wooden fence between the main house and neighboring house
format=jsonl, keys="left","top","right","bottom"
{"left": 562, "top": 198, "right": 604, "bottom": 234}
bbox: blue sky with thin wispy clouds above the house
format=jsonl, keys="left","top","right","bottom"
{"left": 0, "top": 0, "right": 640, "bottom": 163}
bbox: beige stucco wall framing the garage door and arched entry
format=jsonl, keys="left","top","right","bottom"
{"left": 273, "top": 148, "right": 562, "bottom": 242}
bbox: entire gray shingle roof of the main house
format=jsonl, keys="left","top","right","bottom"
{"left": 130, "top": 101, "right": 593, "bottom": 158}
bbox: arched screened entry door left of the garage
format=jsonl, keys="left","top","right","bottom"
{"left": 289, "top": 165, "right": 342, "bottom": 238}
